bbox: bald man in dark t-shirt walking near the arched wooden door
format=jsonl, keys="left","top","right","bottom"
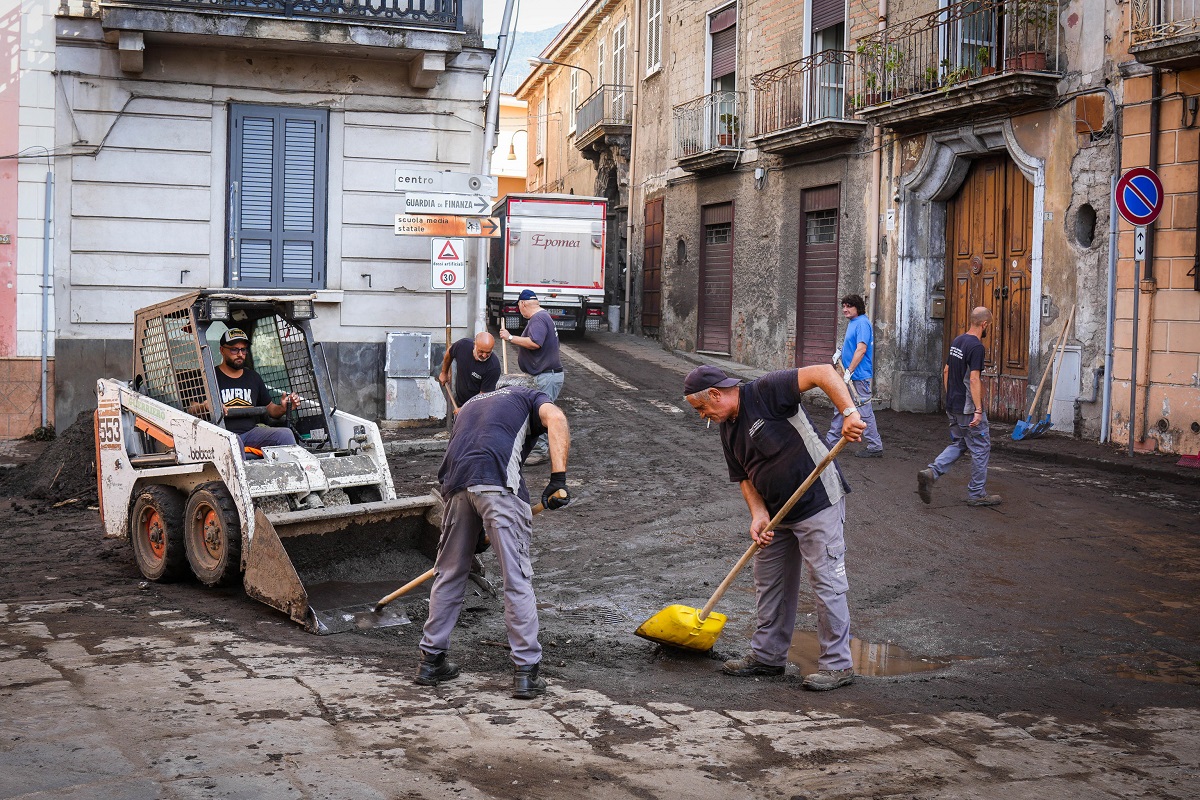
{"left": 917, "top": 306, "right": 1000, "bottom": 506}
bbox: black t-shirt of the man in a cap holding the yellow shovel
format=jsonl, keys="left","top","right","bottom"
{"left": 721, "top": 369, "right": 850, "bottom": 525}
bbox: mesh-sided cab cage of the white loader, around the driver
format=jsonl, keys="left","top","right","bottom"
{"left": 133, "top": 290, "right": 338, "bottom": 450}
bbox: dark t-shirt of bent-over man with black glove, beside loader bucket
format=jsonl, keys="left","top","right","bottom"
{"left": 438, "top": 386, "right": 550, "bottom": 503}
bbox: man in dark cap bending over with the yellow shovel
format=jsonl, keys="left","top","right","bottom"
{"left": 684, "top": 365, "right": 866, "bottom": 691}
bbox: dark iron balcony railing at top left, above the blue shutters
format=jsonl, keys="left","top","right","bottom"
{"left": 102, "top": 0, "right": 462, "bottom": 30}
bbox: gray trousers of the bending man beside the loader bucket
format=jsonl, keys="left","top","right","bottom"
{"left": 421, "top": 487, "right": 541, "bottom": 667}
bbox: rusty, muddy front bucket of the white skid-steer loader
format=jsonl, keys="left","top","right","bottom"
{"left": 244, "top": 494, "right": 442, "bottom": 633}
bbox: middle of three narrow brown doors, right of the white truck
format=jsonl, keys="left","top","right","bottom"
{"left": 696, "top": 203, "right": 733, "bottom": 355}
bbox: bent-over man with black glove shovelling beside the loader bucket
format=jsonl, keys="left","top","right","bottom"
{"left": 415, "top": 386, "right": 571, "bottom": 700}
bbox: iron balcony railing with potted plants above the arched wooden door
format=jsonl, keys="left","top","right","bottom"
{"left": 851, "top": 0, "right": 1062, "bottom": 108}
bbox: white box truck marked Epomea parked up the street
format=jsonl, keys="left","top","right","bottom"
{"left": 487, "top": 194, "right": 607, "bottom": 336}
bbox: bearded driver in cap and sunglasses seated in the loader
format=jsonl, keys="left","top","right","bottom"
{"left": 206, "top": 327, "right": 300, "bottom": 447}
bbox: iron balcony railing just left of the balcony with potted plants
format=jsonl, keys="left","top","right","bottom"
{"left": 750, "top": 50, "right": 854, "bottom": 136}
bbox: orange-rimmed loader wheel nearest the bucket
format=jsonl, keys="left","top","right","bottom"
{"left": 184, "top": 481, "right": 241, "bottom": 587}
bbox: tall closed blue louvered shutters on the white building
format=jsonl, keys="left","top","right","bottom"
{"left": 227, "top": 106, "right": 329, "bottom": 289}
